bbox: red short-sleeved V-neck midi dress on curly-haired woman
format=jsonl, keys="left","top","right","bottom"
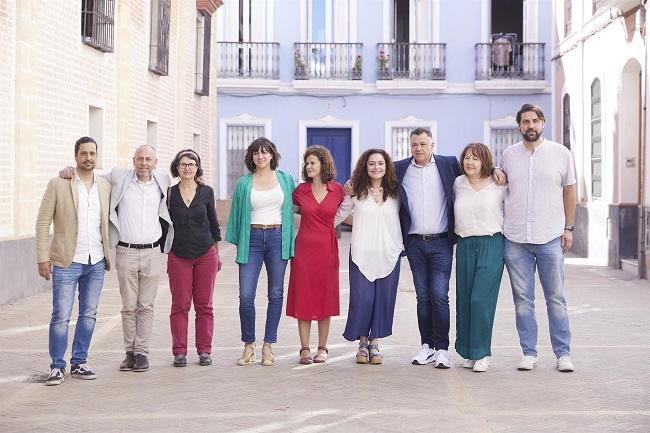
{"left": 287, "top": 182, "right": 345, "bottom": 320}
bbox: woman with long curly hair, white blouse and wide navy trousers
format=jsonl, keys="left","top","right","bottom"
{"left": 334, "top": 149, "right": 402, "bottom": 364}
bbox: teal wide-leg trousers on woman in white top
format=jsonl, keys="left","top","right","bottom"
{"left": 456, "top": 233, "right": 504, "bottom": 360}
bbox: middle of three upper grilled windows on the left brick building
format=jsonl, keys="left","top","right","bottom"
{"left": 149, "top": 0, "right": 172, "bottom": 75}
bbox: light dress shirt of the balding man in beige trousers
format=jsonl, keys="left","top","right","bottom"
{"left": 117, "top": 173, "right": 162, "bottom": 244}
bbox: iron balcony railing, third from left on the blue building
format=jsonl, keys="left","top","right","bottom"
{"left": 377, "top": 42, "right": 446, "bottom": 80}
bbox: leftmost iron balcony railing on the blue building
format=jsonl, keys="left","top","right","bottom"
{"left": 217, "top": 42, "right": 280, "bottom": 80}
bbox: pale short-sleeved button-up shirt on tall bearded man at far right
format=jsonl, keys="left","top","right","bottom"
{"left": 501, "top": 140, "right": 576, "bottom": 244}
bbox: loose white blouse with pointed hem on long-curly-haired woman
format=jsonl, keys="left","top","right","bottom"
{"left": 334, "top": 195, "right": 403, "bottom": 282}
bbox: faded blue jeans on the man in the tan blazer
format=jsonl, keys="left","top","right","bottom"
{"left": 49, "top": 260, "right": 105, "bottom": 369}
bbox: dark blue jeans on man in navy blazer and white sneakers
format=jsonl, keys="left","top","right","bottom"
{"left": 406, "top": 236, "right": 453, "bottom": 350}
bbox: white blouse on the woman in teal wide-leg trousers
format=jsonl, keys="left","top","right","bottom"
{"left": 454, "top": 176, "right": 507, "bottom": 238}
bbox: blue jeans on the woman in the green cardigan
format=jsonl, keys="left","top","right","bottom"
{"left": 239, "top": 228, "right": 287, "bottom": 343}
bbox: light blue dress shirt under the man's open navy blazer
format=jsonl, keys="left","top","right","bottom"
{"left": 402, "top": 155, "right": 448, "bottom": 235}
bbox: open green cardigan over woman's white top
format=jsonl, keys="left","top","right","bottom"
{"left": 226, "top": 170, "right": 296, "bottom": 264}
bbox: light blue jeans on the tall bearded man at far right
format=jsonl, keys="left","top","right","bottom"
{"left": 504, "top": 238, "right": 571, "bottom": 358}
